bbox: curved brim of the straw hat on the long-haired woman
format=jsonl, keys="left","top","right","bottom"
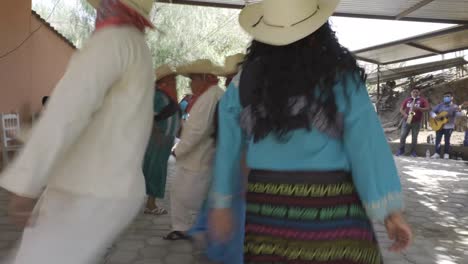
{"left": 239, "top": 0, "right": 340, "bottom": 46}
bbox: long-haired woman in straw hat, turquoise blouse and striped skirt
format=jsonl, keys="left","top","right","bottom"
{"left": 210, "top": 0, "right": 412, "bottom": 264}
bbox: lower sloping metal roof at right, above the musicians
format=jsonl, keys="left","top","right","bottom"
{"left": 353, "top": 25, "right": 468, "bottom": 64}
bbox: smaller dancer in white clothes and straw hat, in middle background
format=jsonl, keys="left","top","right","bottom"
{"left": 164, "top": 60, "right": 224, "bottom": 240}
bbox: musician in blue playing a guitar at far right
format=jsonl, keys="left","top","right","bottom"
{"left": 430, "top": 92, "right": 462, "bottom": 159}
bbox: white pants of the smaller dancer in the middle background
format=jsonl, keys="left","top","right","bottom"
{"left": 171, "top": 166, "right": 211, "bottom": 232}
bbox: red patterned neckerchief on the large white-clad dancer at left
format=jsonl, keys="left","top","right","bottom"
{"left": 96, "top": 0, "right": 153, "bottom": 31}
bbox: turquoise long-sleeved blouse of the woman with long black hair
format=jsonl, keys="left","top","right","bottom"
{"left": 212, "top": 71, "right": 403, "bottom": 220}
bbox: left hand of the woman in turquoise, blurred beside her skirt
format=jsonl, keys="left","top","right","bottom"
{"left": 208, "top": 208, "right": 234, "bottom": 242}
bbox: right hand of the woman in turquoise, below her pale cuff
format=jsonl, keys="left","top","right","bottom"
{"left": 385, "top": 213, "right": 413, "bottom": 252}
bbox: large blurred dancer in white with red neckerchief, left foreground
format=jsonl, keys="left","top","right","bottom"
{"left": 0, "top": 0, "right": 154, "bottom": 264}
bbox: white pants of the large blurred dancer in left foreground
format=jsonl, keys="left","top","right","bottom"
{"left": 6, "top": 189, "right": 144, "bottom": 264}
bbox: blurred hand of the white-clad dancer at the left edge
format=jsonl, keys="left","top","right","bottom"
{"left": 8, "top": 194, "right": 36, "bottom": 227}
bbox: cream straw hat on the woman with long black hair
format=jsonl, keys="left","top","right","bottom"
{"left": 239, "top": 0, "right": 340, "bottom": 46}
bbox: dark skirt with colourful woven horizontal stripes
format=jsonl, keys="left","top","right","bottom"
{"left": 244, "top": 170, "right": 382, "bottom": 264}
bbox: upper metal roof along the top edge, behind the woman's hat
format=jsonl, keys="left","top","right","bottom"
{"left": 159, "top": 0, "right": 468, "bottom": 24}
